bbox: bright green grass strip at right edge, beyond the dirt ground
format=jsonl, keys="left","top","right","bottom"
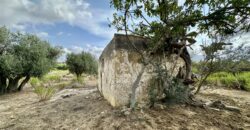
{"left": 207, "top": 72, "right": 250, "bottom": 91}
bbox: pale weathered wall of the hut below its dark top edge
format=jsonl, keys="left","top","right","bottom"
{"left": 98, "top": 47, "right": 185, "bottom": 107}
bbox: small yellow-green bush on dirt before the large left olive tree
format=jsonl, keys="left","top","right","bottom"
{"left": 34, "top": 86, "right": 56, "bottom": 101}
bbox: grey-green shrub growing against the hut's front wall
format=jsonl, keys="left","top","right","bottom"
{"left": 148, "top": 64, "right": 190, "bottom": 105}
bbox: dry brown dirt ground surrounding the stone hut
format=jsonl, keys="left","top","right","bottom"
{"left": 0, "top": 80, "right": 250, "bottom": 130}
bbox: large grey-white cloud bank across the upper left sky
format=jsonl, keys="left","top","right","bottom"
{"left": 0, "top": 0, "right": 114, "bottom": 37}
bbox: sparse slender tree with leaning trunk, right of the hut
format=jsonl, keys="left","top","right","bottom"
{"left": 195, "top": 42, "right": 250, "bottom": 94}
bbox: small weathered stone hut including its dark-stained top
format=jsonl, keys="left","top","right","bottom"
{"left": 98, "top": 34, "right": 185, "bottom": 107}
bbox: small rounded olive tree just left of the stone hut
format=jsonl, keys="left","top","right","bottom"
{"left": 66, "top": 52, "right": 97, "bottom": 79}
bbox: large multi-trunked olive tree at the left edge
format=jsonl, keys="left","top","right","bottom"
{"left": 0, "top": 27, "right": 61, "bottom": 93}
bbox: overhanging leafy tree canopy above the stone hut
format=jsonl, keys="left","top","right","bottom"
{"left": 111, "top": 0, "right": 250, "bottom": 51}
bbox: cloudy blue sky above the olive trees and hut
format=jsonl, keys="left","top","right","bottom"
{"left": 0, "top": 0, "right": 250, "bottom": 61}
